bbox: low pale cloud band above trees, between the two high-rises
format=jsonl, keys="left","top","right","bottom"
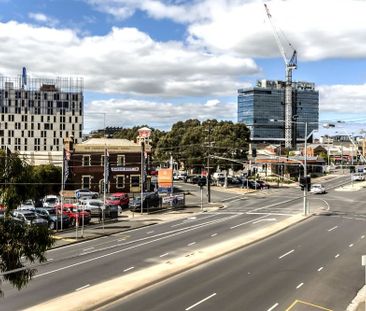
{"left": 84, "top": 99, "right": 236, "bottom": 132}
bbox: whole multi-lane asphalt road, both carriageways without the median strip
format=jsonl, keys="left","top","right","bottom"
{"left": 1, "top": 174, "right": 366, "bottom": 310}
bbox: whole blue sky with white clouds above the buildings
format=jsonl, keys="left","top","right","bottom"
{"left": 0, "top": 0, "right": 366, "bottom": 135}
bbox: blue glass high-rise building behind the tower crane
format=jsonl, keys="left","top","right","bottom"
{"left": 238, "top": 80, "right": 319, "bottom": 145}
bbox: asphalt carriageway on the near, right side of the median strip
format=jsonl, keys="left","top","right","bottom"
{"left": 103, "top": 178, "right": 366, "bottom": 311}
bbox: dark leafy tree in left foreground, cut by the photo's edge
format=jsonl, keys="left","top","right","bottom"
{"left": 0, "top": 150, "right": 54, "bottom": 295}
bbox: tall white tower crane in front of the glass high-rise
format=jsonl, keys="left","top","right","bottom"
{"left": 264, "top": 3, "right": 298, "bottom": 149}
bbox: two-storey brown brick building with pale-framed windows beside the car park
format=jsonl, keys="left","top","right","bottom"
{"left": 65, "top": 138, "right": 151, "bottom": 193}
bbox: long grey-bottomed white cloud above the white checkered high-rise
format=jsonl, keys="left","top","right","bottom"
{"left": 0, "top": 22, "right": 259, "bottom": 97}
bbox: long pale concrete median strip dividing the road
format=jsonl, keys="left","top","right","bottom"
{"left": 26, "top": 215, "right": 307, "bottom": 311}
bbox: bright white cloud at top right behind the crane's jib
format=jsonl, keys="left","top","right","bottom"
{"left": 87, "top": 0, "right": 366, "bottom": 60}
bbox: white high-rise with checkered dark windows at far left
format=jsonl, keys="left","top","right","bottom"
{"left": 0, "top": 68, "right": 84, "bottom": 153}
